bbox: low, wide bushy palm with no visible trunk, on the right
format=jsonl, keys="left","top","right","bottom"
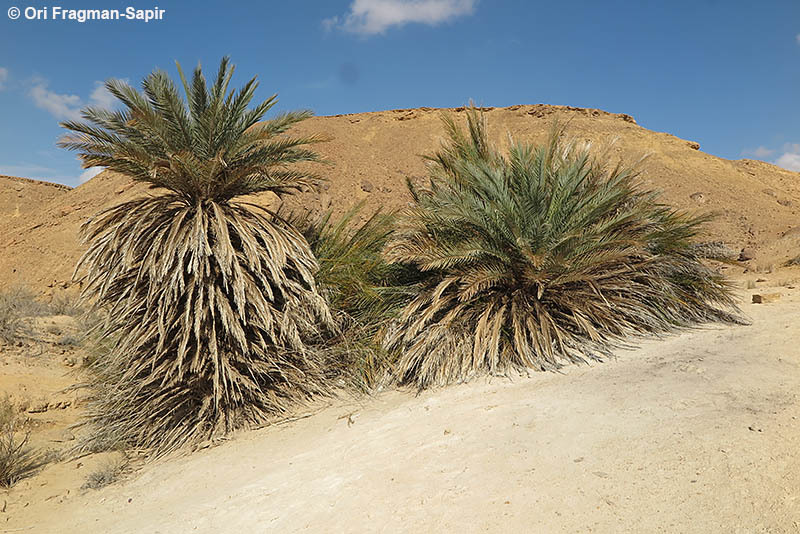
{"left": 385, "top": 109, "right": 738, "bottom": 387}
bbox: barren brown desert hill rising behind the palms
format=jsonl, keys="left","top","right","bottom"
{"left": 0, "top": 105, "right": 800, "bottom": 290}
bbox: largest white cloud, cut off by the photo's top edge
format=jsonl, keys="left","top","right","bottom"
{"left": 322, "top": 0, "right": 477, "bottom": 35}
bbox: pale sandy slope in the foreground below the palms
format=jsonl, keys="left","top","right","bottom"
{"left": 7, "top": 288, "right": 800, "bottom": 534}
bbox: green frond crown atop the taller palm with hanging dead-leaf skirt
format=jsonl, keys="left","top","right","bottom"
{"left": 60, "top": 58, "right": 319, "bottom": 202}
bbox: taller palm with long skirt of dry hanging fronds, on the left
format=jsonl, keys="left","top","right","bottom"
{"left": 60, "top": 58, "right": 331, "bottom": 452}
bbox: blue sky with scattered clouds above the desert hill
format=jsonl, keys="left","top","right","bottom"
{"left": 0, "top": 0, "right": 800, "bottom": 186}
